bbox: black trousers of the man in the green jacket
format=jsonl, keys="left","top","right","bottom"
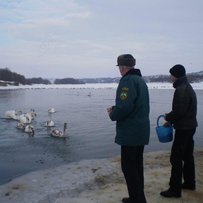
{"left": 121, "top": 146, "right": 146, "bottom": 203}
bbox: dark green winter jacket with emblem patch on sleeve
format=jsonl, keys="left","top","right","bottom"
{"left": 110, "top": 69, "right": 150, "bottom": 146}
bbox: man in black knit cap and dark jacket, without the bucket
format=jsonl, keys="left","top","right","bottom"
{"left": 160, "top": 64, "right": 197, "bottom": 197}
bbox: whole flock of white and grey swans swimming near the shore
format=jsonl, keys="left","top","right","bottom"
{"left": 5, "top": 108, "right": 67, "bottom": 138}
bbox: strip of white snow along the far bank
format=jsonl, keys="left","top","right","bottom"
{"left": 0, "top": 82, "right": 203, "bottom": 90}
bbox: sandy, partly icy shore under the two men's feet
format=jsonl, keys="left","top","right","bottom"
{"left": 0, "top": 148, "right": 203, "bottom": 203}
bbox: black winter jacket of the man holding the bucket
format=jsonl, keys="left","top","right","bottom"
{"left": 165, "top": 77, "right": 197, "bottom": 130}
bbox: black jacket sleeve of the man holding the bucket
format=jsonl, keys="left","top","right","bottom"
{"left": 165, "top": 86, "right": 190, "bottom": 123}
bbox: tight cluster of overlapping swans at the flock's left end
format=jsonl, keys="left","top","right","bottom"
{"left": 5, "top": 109, "right": 37, "bottom": 135}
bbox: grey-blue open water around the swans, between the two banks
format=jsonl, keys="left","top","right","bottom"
{"left": 0, "top": 88, "right": 203, "bottom": 184}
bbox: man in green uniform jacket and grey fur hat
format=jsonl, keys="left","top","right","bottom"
{"left": 107, "top": 54, "right": 150, "bottom": 203}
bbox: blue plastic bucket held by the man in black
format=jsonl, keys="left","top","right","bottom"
{"left": 156, "top": 115, "right": 173, "bottom": 142}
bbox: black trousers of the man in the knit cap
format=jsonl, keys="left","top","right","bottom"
{"left": 169, "top": 129, "right": 196, "bottom": 193}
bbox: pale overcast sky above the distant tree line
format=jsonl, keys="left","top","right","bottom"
{"left": 0, "top": 0, "right": 203, "bottom": 78}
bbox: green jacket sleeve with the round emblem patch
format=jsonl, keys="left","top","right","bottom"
{"left": 110, "top": 80, "right": 137, "bottom": 121}
